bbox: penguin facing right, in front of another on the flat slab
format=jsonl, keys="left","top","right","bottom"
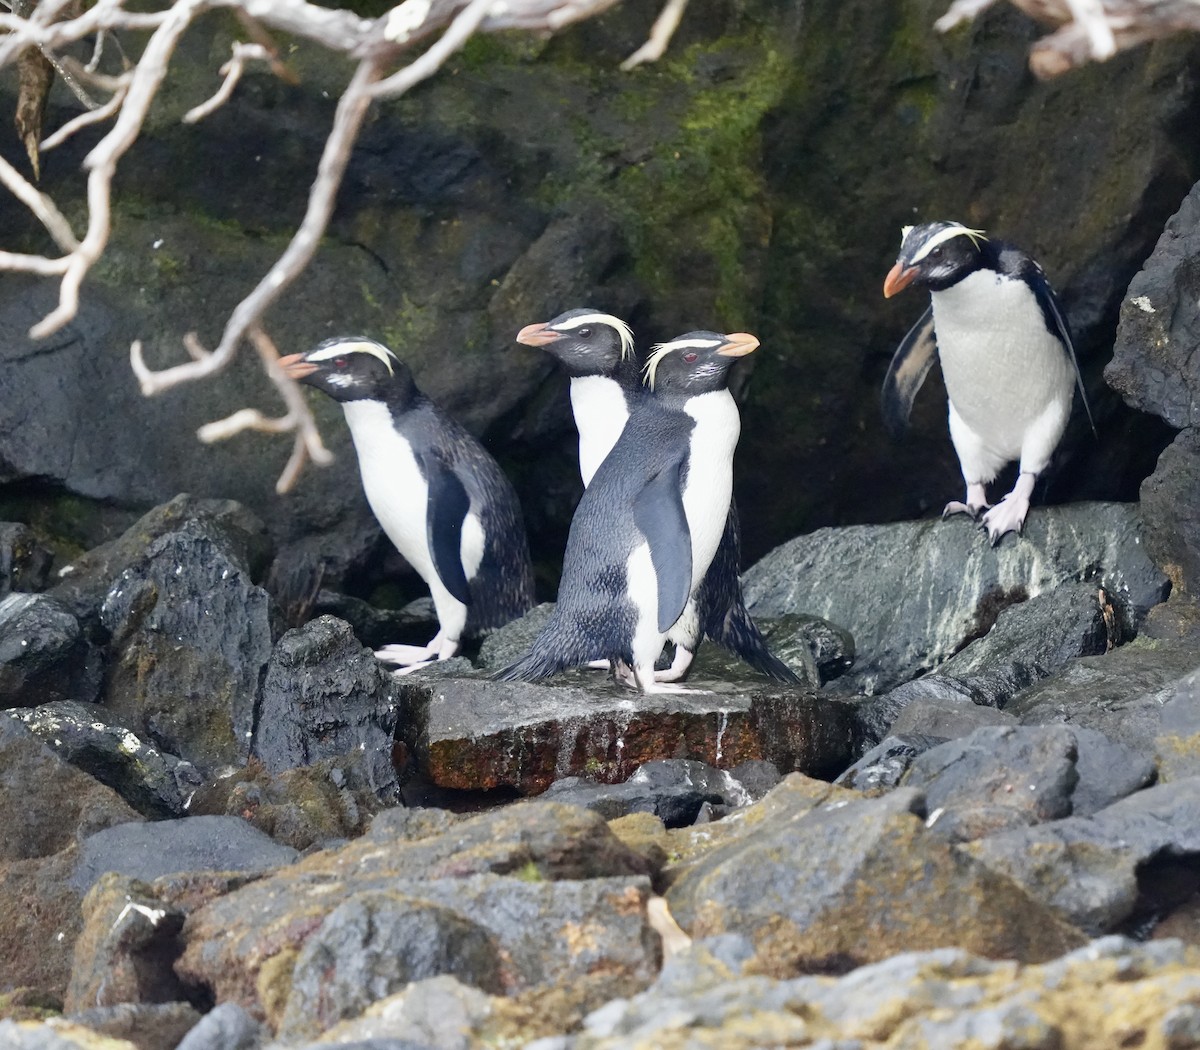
{"left": 496, "top": 331, "right": 758, "bottom": 692}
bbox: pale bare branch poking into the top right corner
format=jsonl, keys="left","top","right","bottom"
{"left": 934, "top": 0, "right": 1200, "bottom": 79}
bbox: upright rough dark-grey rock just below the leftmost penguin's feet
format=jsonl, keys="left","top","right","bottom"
{"left": 252, "top": 616, "right": 400, "bottom": 800}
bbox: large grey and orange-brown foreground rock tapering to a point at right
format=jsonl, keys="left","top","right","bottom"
{"left": 667, "top": 775, "right": 1082, "bottom": 976}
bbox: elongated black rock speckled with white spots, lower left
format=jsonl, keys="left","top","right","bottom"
{"left": 7, "top": 701, "right": 202, "bottom": 817}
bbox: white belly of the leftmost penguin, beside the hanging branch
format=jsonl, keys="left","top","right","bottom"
{"left": 342, "top": 401, "right": 437, "bottom": 583}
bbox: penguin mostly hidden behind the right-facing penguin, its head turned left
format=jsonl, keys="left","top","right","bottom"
{"left": 517, "top": 307, "right": 803, "bottom": 685}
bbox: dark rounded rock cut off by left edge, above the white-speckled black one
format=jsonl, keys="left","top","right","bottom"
{"left": 0, "top": 593, "right": 101, "bottom": 707}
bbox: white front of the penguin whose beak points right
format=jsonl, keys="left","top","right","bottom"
{"left": 683, "top": 390, "right": 742, "bottom": 592}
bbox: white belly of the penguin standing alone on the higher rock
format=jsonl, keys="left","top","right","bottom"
{"left": 931, "top": 270, "right": 1074, "bottom": 458}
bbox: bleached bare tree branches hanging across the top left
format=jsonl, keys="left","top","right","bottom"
{"left": 0, "top": 0, "right": 686, "bottom": 491}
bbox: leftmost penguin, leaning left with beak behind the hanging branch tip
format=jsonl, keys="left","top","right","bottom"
{"left": 280, "top": 336, "right": 533, "bottom": 674}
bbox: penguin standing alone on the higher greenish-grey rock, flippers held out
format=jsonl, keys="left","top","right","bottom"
{"left": 882, "top": 222, "right": 1096, "bottom": 546}
